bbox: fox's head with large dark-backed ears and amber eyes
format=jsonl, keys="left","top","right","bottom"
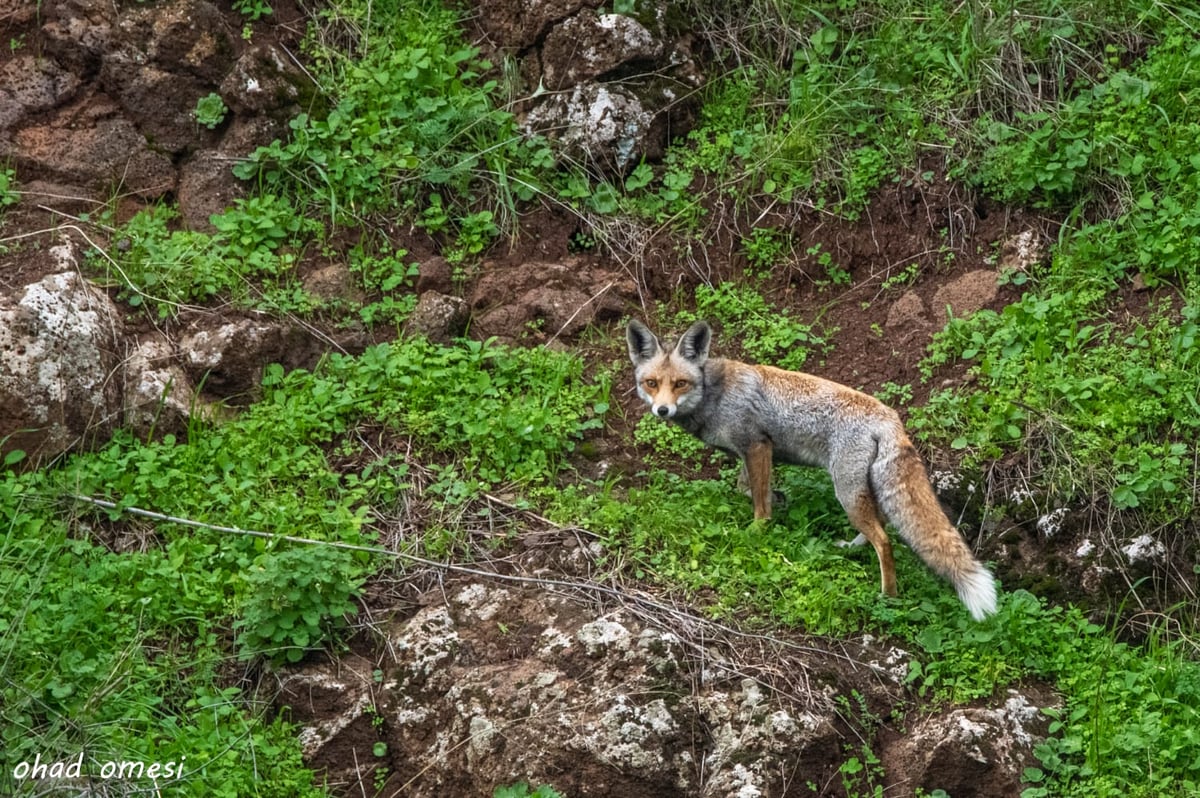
{"left": 625, "top": 319, "right": 713, "bottom": 419}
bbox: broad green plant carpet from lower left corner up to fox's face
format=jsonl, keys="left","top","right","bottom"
{"left": 0, "top": 340, "right": 607, "bottom": 796}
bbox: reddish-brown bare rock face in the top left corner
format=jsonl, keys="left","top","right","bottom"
{"left": 0, "top": 0, "right": 306, "bottom": 218}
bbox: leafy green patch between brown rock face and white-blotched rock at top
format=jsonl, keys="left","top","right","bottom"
{"left": 235, "top": 1, "right": 552, "bottom": 242}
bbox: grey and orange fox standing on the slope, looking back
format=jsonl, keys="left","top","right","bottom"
{"left": 625, "top": 319, "right": 996, "bottom": 620}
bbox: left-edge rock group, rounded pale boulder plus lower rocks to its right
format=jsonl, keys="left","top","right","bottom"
{"left": 0, "top": 249, "right": 345, "bottom": 463}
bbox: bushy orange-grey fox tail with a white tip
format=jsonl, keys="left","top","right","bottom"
{"left": 871, "top": 437, "right": 996, "bottom": 620}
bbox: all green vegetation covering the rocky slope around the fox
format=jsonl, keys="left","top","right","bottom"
{"left": 0, "top": 0, "right": 1200, "bottom": 798}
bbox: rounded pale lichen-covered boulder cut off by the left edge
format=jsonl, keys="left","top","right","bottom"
{"left": 0, "top": 264, "right": 122, "bottom": 458}
